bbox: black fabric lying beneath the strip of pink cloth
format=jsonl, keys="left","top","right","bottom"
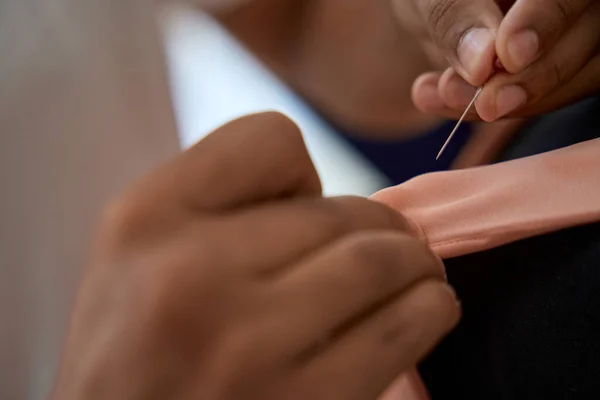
{"left": 420, "top": 97, "right": 600, "bottom": 400}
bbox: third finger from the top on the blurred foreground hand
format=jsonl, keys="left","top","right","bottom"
{"left": 273, "top": 231, "right": 445, "bottom": 354}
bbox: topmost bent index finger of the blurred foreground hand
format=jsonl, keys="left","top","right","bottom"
{"left": 132, "top": 113, "right": 321, "bottom": 210}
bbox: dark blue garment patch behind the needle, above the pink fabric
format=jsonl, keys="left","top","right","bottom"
{"left": 337, "top": 121, "right": 473, "bottom": 185}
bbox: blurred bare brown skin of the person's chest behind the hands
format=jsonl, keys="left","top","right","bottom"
{"left": 211, "top": 0, "right": 445, "bottom": 138}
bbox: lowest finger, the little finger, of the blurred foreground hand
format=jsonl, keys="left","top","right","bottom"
{"left": 299, "top": 280, "right": 460, "bottom": 400}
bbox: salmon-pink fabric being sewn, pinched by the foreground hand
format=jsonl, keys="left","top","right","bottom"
{"left": 373, "top": 139, "right": 600, "bottom": 400}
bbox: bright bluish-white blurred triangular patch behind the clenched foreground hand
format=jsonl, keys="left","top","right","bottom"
{"left": 159, "top": 6, "right": 389, "bottom": 196}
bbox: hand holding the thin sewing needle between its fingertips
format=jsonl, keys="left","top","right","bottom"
{"left": 394, "top": 0, "right": 600, "bottom": 121}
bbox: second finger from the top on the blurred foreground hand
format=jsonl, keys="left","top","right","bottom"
{"left": 213, "top": 197, "right": 416, "bottom": 276}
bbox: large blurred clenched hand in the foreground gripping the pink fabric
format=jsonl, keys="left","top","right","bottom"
{"left": 54, "top": 114, "right": 459, "bottom": 400}
